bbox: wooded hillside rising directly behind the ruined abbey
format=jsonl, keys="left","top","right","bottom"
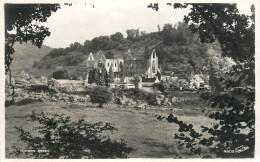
{"left": 34, "top": 23, "right": 221, "bottom": 75}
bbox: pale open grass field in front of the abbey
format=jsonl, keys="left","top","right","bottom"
{"left": 5, "top": 102, "right": 213, "bottom": 158}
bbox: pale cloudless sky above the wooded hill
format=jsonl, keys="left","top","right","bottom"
{"left": 43, "top": 1, "right": 253, "bottom": 48}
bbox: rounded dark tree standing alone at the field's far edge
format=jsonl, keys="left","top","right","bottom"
{"left": 90, "top": 86, "right": 112, "bottom": 108}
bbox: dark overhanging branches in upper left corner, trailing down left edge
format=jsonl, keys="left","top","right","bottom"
{"left": 4, "top": 4, "right": 60, "bottom": 97}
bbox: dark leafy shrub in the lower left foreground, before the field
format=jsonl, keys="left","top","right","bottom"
{"left": 12, "top": 112, "right": 133, "bottom": 159}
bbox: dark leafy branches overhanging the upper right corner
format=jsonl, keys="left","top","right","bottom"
{"left": 170, "top": 3, "right": 255, "bottom": 62}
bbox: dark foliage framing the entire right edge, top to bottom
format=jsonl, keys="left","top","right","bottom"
{"left": 148, "top": 3, "right": 255, "bottom": 158}
